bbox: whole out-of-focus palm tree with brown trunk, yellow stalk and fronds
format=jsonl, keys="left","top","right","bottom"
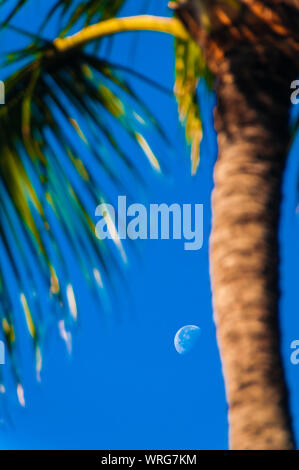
{"left": 0, "top": 0, "right": 299, "bottom": 449}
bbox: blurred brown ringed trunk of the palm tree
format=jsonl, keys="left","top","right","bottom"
{"left": 180, "top": 0, "right": 299, "bottom": 449}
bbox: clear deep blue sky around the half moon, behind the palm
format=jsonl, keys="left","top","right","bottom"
{"left": 0, "top": 0, "right": 299, "bottom": 449}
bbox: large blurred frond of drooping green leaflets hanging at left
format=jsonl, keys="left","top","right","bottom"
{"left": 0, "top": 35, "right": 166, "bottom": 402}
